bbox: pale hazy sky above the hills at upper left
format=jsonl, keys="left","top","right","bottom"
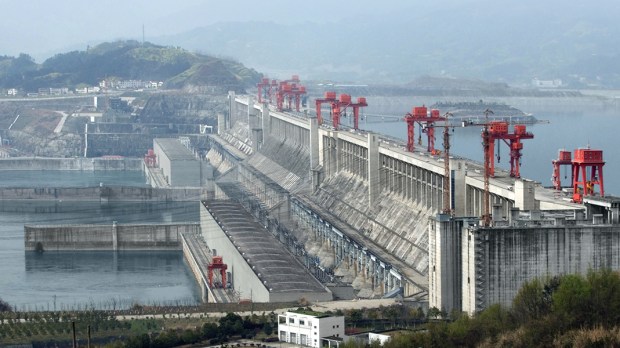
{"left": 0, "top": 0, "right": 411, "bottom": 63}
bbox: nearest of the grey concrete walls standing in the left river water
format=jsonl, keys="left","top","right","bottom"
{"left": 24, "top": 223, "right": 200, "bottom": 252}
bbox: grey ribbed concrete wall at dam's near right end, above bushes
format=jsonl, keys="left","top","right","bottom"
{"left": 461, "top": 225, "right": 620, "bottom": 313}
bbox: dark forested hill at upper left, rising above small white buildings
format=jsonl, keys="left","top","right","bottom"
{"left": 0, "top": 41, "right": 260, "bottom": 92}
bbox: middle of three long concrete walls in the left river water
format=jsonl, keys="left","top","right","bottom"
{"left": 0, "top": 186, "right": 207, "bottom": 203}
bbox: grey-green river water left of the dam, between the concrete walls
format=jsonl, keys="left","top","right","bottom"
{"left": 0, "top": 171, "right": 199, "bottom": 310}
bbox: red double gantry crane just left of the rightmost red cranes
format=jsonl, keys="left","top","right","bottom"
{"left": 482, "top": 121, "right": 534, "bottom": 178}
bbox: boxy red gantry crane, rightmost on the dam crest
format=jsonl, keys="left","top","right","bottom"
{"left": 572, "top": 149, "right": 605, "bottom": 203}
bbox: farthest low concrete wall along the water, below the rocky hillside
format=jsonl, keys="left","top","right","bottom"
{"left": 0, "top": 157, "right": 143, "bottom": 171}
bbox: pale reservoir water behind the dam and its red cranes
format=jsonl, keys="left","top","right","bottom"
{"left": 358, "top": 93, "right": 620, "bottom": 196}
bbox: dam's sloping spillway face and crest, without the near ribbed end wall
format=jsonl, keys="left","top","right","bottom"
{"left": 203, "top": 92, "right": 604, "bottom": 299}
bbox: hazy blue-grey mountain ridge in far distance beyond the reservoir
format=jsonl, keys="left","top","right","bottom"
{"left": 157, "top": 0, "right": 620, "bottom": 88}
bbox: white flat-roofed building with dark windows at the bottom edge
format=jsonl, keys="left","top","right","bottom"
{"left": 278, "top": 310, "right": 345, "bottom": 347}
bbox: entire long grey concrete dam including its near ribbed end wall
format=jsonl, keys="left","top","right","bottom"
{"left": 202, "top": 93, "right": 620, "bottom": 313}
